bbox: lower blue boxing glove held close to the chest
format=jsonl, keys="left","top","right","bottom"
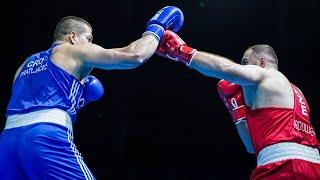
{"left": 83, "top": 75, "right": 104, "bottom": 104}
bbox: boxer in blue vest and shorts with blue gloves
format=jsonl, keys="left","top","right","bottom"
{"left": 0, "top": 6, "right": 183, "bottom": 180}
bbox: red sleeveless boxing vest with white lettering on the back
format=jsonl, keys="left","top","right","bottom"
{"left": 247, "top": 85, "right": 320, "bottom": 155}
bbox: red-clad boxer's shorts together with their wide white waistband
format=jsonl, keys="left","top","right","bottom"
{"left": 250, "top": 142, "right": 320, "bottom": 180}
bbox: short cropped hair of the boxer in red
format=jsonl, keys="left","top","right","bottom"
{"left": 249, "top": 44, "right": 278, "bottom": 65}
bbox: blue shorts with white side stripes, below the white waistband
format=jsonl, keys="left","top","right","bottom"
{"left": 0, "top": 122, "right": 95, "bottom": 180}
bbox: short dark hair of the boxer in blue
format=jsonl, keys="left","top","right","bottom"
{"left": 53, "top": 16, "right": 92, "bottom": 41}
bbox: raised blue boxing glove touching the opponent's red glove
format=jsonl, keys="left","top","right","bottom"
{"left": 142, "top": 6, "right": 184, "bottom": 41}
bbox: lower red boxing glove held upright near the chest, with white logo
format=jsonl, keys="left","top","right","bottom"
{"left": 217, "top": 79, "right": 247, "bottom": 124}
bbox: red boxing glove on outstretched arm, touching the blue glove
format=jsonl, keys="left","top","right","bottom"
{"left": 156, "top": 30, "right": 197, "bottom": 65}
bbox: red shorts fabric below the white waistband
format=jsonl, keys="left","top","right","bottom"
{"left": 250, "top": 159, "right": 320, "bottom": 180}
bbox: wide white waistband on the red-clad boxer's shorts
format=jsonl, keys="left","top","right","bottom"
{"left": 257, "top": 142, "right": 320, "bottom": 166}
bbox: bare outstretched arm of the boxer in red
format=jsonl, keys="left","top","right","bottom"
{"left": 189, "top": 51, "right": 264, "bottom": 86}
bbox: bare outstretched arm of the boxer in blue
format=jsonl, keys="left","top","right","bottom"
{"left": 72, "top": 35, "right": 158, "bottom": 69}
